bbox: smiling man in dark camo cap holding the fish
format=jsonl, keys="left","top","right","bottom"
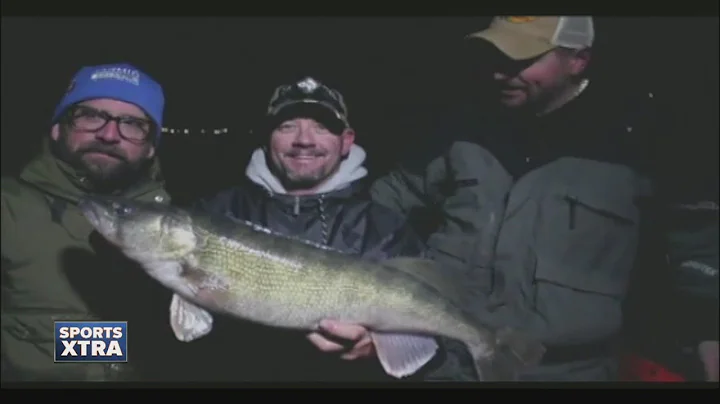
{"left": 191, "top": 77, "right": 424, "bottom": 381}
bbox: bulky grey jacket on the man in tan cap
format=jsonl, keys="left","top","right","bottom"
{"left": 372, "top": 83, "right": 718, "bottom": 380}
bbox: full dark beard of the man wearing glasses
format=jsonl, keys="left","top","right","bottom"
{"left": 53, "top": 133, "right": 150, "bottom": 193}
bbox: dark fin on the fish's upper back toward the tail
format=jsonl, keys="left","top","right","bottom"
{"left": 380, "top": 257, "right": 463, "bottom": 303}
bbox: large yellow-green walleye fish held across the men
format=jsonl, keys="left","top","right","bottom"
{"left": 80, "top": 197, "right": 544, "bottom": 381}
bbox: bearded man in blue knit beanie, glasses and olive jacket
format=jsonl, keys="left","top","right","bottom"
{"left": 1, "top": 64, "right": 180, "bottom": 381}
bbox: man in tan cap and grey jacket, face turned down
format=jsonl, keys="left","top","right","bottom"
{"left": 372, "top": 16, "right": 718, "bottom": 381}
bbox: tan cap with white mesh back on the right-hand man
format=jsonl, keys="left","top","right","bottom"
{"left": 467, "top": 16, "right": 595, "bottom": 60}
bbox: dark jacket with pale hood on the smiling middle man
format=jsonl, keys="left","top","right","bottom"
{"left": 186, "top": 145, "right": 423, "bottom": 381}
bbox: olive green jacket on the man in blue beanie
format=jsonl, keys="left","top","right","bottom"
{"left": 1, "top": 142, "right": 176, "bottom": 381}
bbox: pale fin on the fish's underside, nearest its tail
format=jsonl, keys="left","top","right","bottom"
{"left": 372, "top": 333, "right": 438, "bottom": 379}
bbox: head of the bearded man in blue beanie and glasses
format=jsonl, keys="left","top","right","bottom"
{"left": 51, "top": 64, "right": 165, "bottom": 191}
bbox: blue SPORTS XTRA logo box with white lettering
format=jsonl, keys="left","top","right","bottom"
{"left": 55, "top": 321, "right": 128, "bottom": 362}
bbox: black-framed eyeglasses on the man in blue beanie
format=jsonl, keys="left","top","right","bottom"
{"left": 67, "top": 105, "right": 155, "bottom": 142}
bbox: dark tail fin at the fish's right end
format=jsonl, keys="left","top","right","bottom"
{"left": 468, "top": 328, "right": 545, "bottom": 381}
